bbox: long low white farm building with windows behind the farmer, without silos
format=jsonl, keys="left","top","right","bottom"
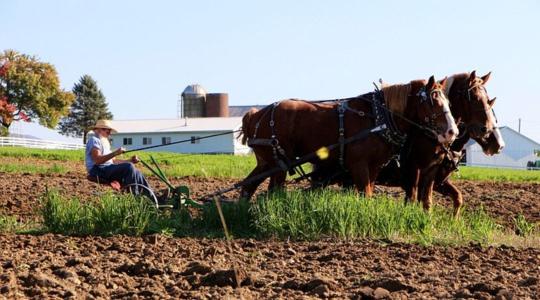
{"left": 111, "top": 117, "right": 249, "bottom": 154}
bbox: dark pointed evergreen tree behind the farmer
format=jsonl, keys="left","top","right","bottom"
{"left": 59, "top": 75, "right": 113, "bottom": 143}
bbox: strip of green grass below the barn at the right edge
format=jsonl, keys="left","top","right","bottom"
{"left": 453, "top": 166, "right": 540, "bottom": 183}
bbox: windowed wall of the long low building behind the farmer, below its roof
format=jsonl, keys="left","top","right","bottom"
{"left": 111, "top": 131, "right": 249, "bottom": 154}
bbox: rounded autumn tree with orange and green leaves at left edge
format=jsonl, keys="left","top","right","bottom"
{"left": 0, "top": 50, "right": 74, "bottom": 129}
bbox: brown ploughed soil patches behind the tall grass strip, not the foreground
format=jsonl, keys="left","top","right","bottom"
{"left": 0, "top": 172, "right": 540, "bottom": 227}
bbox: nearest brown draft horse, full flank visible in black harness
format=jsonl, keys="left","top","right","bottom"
{"left": 241, "top": 76, "right": 458, "bottom": 199}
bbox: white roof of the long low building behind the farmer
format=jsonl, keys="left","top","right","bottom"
{"left": 111, "top": 117, "right": 242, "bottom": 133}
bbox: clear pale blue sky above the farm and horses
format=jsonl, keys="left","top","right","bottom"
{"left": 0, "top": 0, "right": 540, "bottom": 141}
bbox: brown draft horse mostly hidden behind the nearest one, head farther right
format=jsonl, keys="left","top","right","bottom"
{"left": 316, "top": 71, "right": 504, "bottom": 216}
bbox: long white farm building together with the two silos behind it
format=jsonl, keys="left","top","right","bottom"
{"left": 111, "top": 84, "right": 250, "bottom": 154}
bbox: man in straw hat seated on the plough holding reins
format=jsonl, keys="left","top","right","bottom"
{"left": 85, "top": 120, "right": 150, "bottom": 194}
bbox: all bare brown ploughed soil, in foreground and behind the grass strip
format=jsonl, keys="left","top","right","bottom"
{"left": 0, "top": 166, "right": 540, "bottom": 299}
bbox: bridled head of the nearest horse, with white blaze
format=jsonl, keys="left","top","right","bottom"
{"left": 409, "top": 76, "right": 459, "bottom": 144}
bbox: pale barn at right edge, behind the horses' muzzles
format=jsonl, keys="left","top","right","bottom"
{"left": 465, "top": 126, "right": 540, "bottom": 169}
